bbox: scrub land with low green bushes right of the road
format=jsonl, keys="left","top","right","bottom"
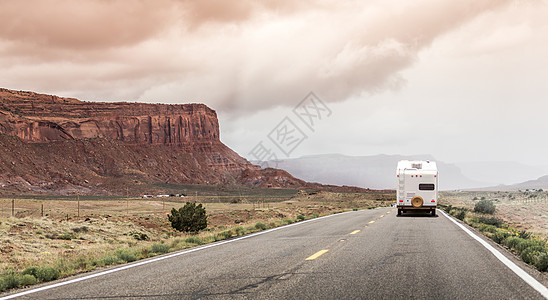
{"left": 440, "top": 191, "right": 548, "bottom": 272}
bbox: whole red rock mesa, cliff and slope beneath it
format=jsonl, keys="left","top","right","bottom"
{"left": 0, "top": 89, "right": 312, "bottom": 194}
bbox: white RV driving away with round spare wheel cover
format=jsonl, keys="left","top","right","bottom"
{"left": 396, "top": 160, "right": 438, "bottom": 216}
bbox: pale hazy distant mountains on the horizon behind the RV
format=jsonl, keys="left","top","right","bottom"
{"left": 260, "top": 154, "right": 548, "bottom": 190}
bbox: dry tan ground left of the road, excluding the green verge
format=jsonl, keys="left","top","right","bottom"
{"left": 0, "top": 191, "right": 395, "bottom": 273}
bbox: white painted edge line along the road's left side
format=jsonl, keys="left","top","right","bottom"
{"left": 0, "top": 211, "right": 356, "bottom": 300}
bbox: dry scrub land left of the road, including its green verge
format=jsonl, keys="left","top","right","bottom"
{"left": 0, "top": 191, "right": 395, "bottom": 291}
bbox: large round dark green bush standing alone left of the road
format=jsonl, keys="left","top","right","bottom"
{"left": 168, "top": 202, "right": 207, "bottom": 232}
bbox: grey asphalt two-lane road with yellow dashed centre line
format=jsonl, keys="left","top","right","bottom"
{"left": 4, "top": 208, "right": 544, "bottom": 299}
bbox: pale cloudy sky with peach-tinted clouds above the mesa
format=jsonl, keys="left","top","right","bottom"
{"left": 0, "top": 0, "right": 548, "bottom": 165}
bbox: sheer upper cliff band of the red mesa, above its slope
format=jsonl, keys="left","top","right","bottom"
{"left": 0, "top": 89, "right": 219, "bottom": 146}
